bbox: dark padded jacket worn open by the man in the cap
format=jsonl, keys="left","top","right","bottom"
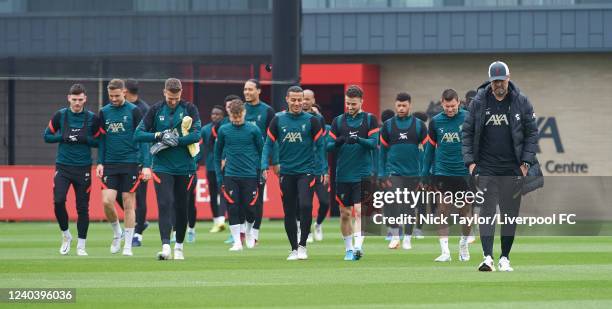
{"left": 462, "top": 82, "right": 543, "bottom": 193}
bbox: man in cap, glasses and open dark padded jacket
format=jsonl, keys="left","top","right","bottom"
{"left": 462, "top": 61, "right": 538, "bottom": 271}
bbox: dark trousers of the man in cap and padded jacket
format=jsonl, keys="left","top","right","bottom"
{"left": 478, "top": 171, "right": 523, "bottom": 258}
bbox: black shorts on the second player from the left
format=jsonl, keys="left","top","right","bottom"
{"left": 102, "top": 164, "right": 140, "bottom": 193}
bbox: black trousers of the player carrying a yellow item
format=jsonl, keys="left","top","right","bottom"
{"left": 154, "top": 173, "right": 194, "bottom": 244}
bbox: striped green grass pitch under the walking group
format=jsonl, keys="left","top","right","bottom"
{"left": 0, "top": 220, "right": 612, "bottom": 308}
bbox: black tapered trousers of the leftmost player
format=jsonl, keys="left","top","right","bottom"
{"left": 53, "top": 164, "right": 91, "bottom": 239}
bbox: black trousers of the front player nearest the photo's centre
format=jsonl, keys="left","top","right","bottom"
{"left": 280, "top": 174, "right": 316, "bottom": 250}
